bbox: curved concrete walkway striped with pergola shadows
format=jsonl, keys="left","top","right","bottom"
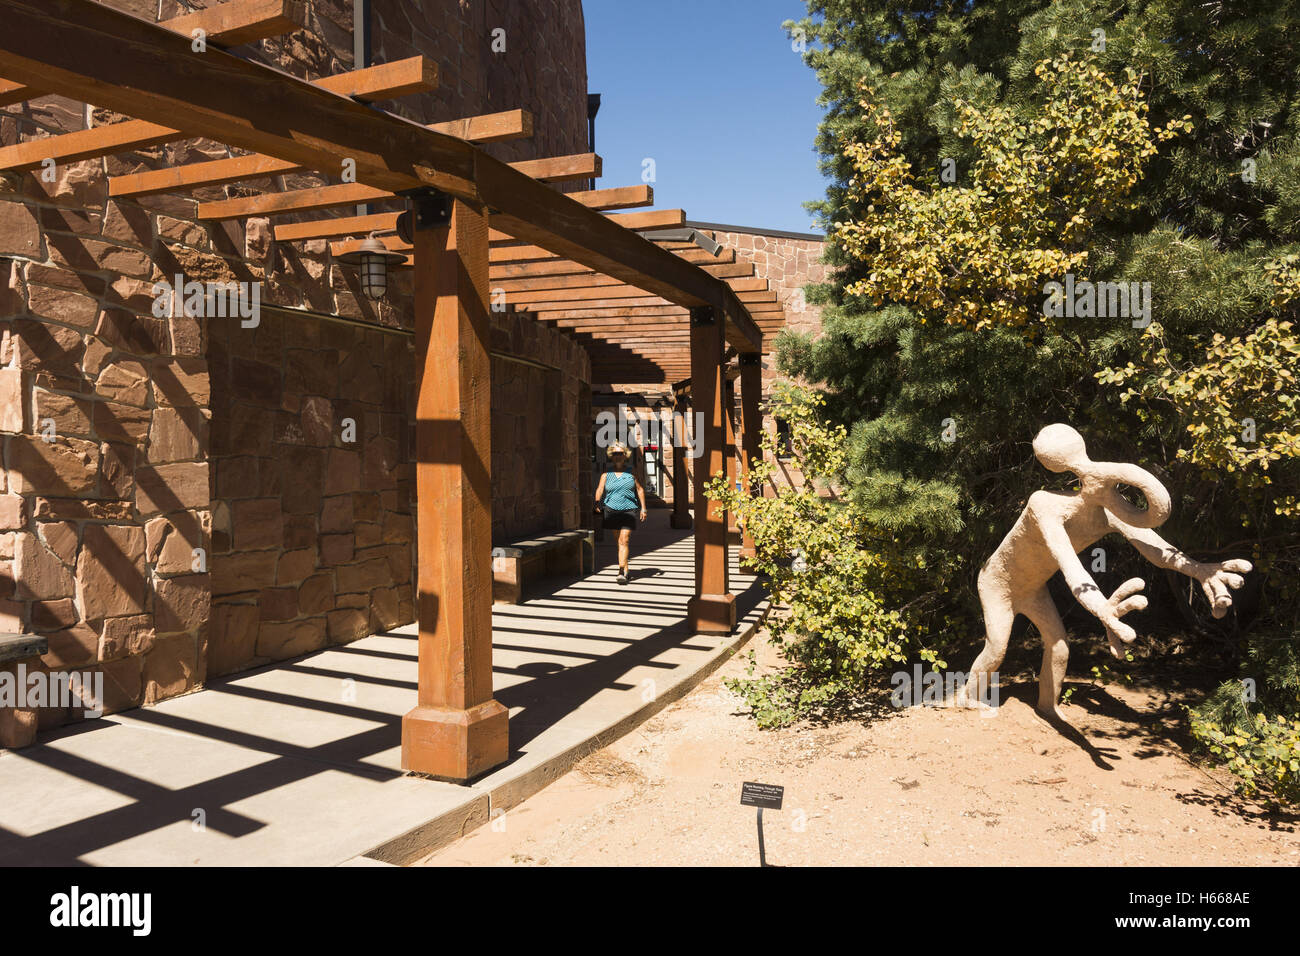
{"left": 0, "top": 510, "right": 766, "bottom": 866}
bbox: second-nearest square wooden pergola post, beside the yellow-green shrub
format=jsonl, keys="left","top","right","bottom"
{"left": 686, "top": 307, "right": 736, "bottom": 633}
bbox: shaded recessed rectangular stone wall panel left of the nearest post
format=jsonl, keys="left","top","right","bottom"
{"left": 208, "top": 311, "right": 415, "bottom": 675}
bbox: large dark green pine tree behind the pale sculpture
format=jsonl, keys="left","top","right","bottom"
{"left": 780, "top": 0, "right": 1300, "bottom": 642}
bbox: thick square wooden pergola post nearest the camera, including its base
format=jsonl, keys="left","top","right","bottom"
{"left": 402, "top": 198, "right": 510, "bottom": 780}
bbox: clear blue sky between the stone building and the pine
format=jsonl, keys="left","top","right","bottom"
{"left": 582, "top": 0, "right": 826, "bottom": 233}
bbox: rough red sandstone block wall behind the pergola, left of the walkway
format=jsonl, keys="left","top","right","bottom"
{"left": 0, "top": 0, "right": 590, "bottom": 745}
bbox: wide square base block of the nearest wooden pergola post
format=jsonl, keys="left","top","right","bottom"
{"left": 402, "top": 700, "right": 510, "bottom": 782}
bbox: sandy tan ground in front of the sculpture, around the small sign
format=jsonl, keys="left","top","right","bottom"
{"left": 421, "top": 635, "right": 1300, "bottom": 866}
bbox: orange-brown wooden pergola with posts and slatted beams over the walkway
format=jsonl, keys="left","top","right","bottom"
{"left": 0, "top": 0, "right": 781, "bottom": 780}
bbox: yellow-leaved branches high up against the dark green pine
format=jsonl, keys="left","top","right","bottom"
{"left": 832, "top": 56, "right": 1191, "bottom": 328}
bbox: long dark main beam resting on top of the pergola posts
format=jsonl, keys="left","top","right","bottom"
{"left": 0, "top": 0, "right": 762, "bottom": 350}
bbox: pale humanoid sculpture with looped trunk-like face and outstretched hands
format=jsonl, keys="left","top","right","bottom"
{"left": 956, "top": 424, "right": 1251, "bottom": 719}
